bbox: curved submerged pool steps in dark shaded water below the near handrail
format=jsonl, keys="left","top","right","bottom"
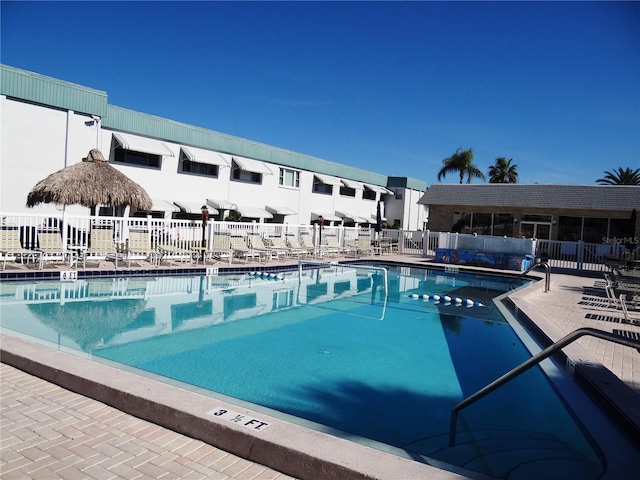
{"left": 406, "top": 431, "right": 603, "bottom": 480}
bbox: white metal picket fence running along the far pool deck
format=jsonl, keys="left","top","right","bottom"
{"left": 0, "top": 213, "right": 640, "bottom": 271}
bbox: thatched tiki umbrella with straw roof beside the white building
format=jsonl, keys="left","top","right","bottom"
{"left": 27, "top": 149, "right": 152, "bottom": 215}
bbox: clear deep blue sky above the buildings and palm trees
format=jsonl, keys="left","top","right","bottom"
{"left": 0, "top": 0, "right": 640, "bottom": 185}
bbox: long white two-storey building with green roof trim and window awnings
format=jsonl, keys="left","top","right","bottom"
{"left": 0, "top": 65, "right": 427, "bottom": 230}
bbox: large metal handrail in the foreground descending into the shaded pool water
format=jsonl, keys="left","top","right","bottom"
{"left": 449, "top": 327, "right": 640, "bottom": 447}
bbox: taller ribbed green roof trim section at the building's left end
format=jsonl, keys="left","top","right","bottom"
{"left": 0, "top": 65, "right": 107, "bottom": 117}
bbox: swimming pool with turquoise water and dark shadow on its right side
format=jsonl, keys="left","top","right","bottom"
{"left": 1, "top": 265, "right": 636, "bottom": 478}
